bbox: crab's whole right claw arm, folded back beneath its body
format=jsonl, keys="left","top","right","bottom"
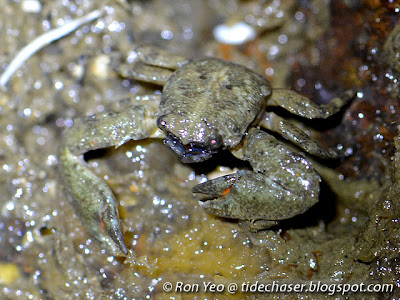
{"left": 193, "top": 129, "right": 321, "bottom": 230}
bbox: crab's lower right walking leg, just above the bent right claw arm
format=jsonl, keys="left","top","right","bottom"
{"left": 260, "top": 112, "right": 339, "bottom": 159}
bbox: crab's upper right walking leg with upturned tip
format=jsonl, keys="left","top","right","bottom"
{"left": 268, "top": 89, "right": 355, "bottom": 119}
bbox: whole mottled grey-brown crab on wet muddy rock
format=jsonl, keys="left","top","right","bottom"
{"left": 59, "top": 45, "right": 353, "bottom": 255}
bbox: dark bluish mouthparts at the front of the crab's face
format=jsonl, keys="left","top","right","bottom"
{"left": 164, "top": 133, "right": 216, "bottom": 163}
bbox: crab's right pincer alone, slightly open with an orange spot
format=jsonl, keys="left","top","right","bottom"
{"left": 192, "top": 166, "right": 319, "bottom": 231}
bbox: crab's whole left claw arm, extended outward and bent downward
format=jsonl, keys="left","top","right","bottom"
{"left": 59, "top": 106, "right": 158, "bottom": 255}
